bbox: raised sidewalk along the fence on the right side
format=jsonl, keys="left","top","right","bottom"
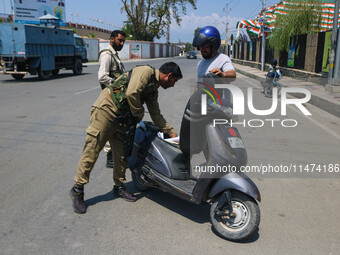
{"left": 233, "top": 63, "right": 340, "bottom": 118}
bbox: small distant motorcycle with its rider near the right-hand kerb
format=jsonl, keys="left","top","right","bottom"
{"left": 261, "top": 59, "right": 282, "bottom": 97}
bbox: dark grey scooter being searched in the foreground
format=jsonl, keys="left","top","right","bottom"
{"left": 128, "top": 77, "right": 261, "bottom": 241}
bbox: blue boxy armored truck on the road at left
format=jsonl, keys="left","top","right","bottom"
{"left": 0, "top": 23, "right": 87, "bottom": 80}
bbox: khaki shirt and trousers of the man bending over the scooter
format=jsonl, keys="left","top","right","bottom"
{"left": 75, "top": 66, "right": 175, "bottom": 187}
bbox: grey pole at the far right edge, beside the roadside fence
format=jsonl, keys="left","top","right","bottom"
{"left": 328, "top": 0, "right": 340, "bottom": 92}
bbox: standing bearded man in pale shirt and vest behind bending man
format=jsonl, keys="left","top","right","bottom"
{"left": 98, "top": 30, "right": 126, "bottom": 168}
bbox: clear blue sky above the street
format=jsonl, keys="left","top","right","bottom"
{"left": 0, "top": 0, "right": 279, "bottom": 42}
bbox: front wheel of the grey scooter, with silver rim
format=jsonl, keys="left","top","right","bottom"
{"left": 210, "top": 191, "right": 261, "bottom": 241}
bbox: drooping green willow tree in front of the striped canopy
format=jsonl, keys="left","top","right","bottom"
{"left": 269, "top": 0, "right": 323, "bottom": 51}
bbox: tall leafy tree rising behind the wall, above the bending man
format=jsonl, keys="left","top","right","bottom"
{"left": 121, "top": 0, "right": 197, "bottom": 41}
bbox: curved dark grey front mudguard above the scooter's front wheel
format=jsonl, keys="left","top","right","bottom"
{"left": 208, "top": 173, "right": 261, "bottom": 202}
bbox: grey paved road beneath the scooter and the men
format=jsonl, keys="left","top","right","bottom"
{"left": 0, "top": 58, "right": 340, "bottom": 255}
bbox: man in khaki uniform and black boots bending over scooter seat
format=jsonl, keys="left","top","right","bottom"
{"left": 70, "top": 62, "right": 182, "bottom": 213}
